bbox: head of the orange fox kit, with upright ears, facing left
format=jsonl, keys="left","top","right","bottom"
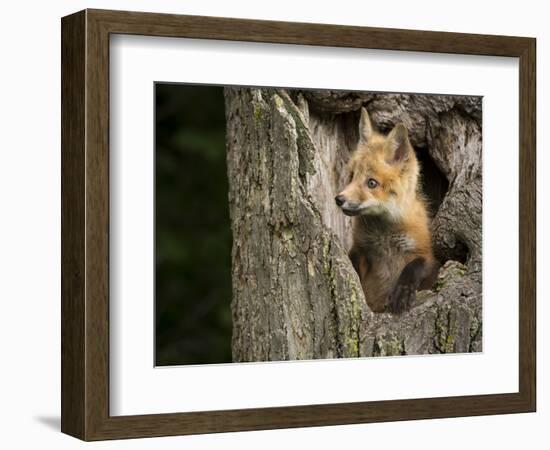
{"left": 335, "top": 108, "right": 418, "bottom": 221}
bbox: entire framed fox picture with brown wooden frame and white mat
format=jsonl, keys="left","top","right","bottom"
{"left": 61, "top": 10, "right": 536, "bottom": 440}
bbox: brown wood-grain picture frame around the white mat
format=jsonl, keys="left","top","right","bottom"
{"left": 61, "top": 10, "right": 536, "bottom": 440}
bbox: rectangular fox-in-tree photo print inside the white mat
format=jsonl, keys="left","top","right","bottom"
{"left": 154, "top": 82, "right": 482, "bottom": 366}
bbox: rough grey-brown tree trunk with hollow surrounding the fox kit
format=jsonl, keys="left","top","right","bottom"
{"left": 225, "top": 88, "right": 482, "bottom": 361}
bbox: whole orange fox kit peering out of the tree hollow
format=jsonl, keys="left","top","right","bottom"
{"left": 335, "top": 108, "right": 436, "bottom": 313}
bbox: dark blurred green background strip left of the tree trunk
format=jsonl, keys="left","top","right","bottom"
{"left": 155, "top": 83, "right": 231, "bottom": 366}
